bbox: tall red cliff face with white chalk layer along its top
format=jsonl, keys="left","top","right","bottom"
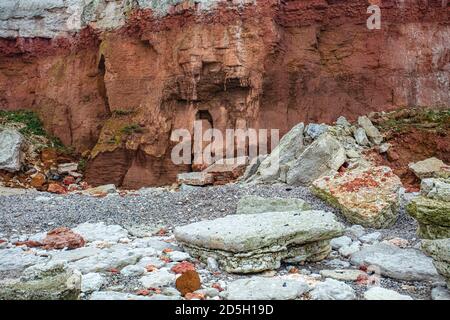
{"left": 0, "top": 0, "right": 450, "bottom": 187}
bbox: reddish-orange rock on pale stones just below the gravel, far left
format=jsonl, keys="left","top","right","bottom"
{"left": 42, "top": 227, "right": 85, "bottom": 250}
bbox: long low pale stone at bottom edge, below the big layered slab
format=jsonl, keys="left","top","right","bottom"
{"left": 225, "top": 277, "right": 309, "bottom": 300}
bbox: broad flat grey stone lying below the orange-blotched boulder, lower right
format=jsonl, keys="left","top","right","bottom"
{"left": 350, "top": 243, "right": 439, "bottom": 281}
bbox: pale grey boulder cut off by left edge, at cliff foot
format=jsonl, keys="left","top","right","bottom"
{"left": 0, "top": 129, "right": 23, "bottom": 172}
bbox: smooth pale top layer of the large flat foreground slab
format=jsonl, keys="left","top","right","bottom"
{"left": 175, "top": 211, "right": 343, "bottom": 253}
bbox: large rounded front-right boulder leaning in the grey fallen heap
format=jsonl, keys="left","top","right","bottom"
{"left": 286, "top": 134, "right": 346, "bottom": 185}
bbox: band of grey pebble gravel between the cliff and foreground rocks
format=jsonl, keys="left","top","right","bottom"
{"left": 0, "top": 184, "right": 417, "bottom": 241}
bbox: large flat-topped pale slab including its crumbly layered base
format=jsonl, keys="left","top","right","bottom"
{"left": 175, "top": 211, "right": 344, "bottom": 273}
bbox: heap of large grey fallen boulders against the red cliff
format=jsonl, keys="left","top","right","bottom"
{"left": 243, "top": 117, "right": 383, "bottom": 186}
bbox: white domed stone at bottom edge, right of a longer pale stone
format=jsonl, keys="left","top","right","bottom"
{"left": 310, "top": 279, "right": 356, "bottom": 300}
